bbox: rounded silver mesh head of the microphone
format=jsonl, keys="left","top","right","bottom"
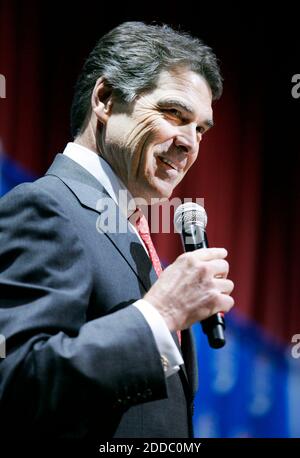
{"left": 174, "top": 202, "right": 207, "bottom": 234}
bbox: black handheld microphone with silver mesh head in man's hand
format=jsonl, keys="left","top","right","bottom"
{"left": 174, "top": 202, "right": 226, "bottom": 348}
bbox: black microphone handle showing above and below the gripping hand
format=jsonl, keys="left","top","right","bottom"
{"left": 181, "top": 224, "right": 226, "bottom": 348}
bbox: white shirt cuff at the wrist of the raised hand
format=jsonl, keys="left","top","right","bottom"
{"left": 132, "top": 299, "right": 184, "bottom": 377}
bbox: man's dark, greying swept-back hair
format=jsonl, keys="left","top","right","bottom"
{"left": 71, "top": 22, "right": 222, "bottom": 137}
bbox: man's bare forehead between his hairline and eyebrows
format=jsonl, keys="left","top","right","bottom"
{"left": 153, "top": 68, "right": 212, "bottom": 116}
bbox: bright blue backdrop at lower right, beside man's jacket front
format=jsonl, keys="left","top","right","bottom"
{"left": 194, "top": 313, "right": 300, "bottom": 438}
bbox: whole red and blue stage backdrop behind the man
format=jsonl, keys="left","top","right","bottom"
{"left": 0, "top": 0, "right": 300, "bottom": 437}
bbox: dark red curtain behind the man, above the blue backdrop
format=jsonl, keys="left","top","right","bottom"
{"left": 0, "top": 0, "right": 300, "bottom": 341}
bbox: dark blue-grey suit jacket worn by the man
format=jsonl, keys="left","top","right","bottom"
{"left": 0, "top": 154, "right": 196, "bottom": 438}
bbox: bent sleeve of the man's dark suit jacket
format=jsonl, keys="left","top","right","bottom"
{"left": 0, "top": 184, "right": 167, "bottom": 434}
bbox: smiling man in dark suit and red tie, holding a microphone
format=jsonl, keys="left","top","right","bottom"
{"left": 0, "top": 22, "right": 233, "bottom": 438}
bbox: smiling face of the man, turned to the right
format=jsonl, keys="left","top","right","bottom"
{"left": 97, "top": 69, "right": 212, "bottom": 203}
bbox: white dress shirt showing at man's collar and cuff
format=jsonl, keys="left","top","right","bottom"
{"left": 63, "top": 143, "right": 183, "bottom": 377}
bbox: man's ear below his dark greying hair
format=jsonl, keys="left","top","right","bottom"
{"left": 91, "top": 76, "right": 112, "bottom": 124}
